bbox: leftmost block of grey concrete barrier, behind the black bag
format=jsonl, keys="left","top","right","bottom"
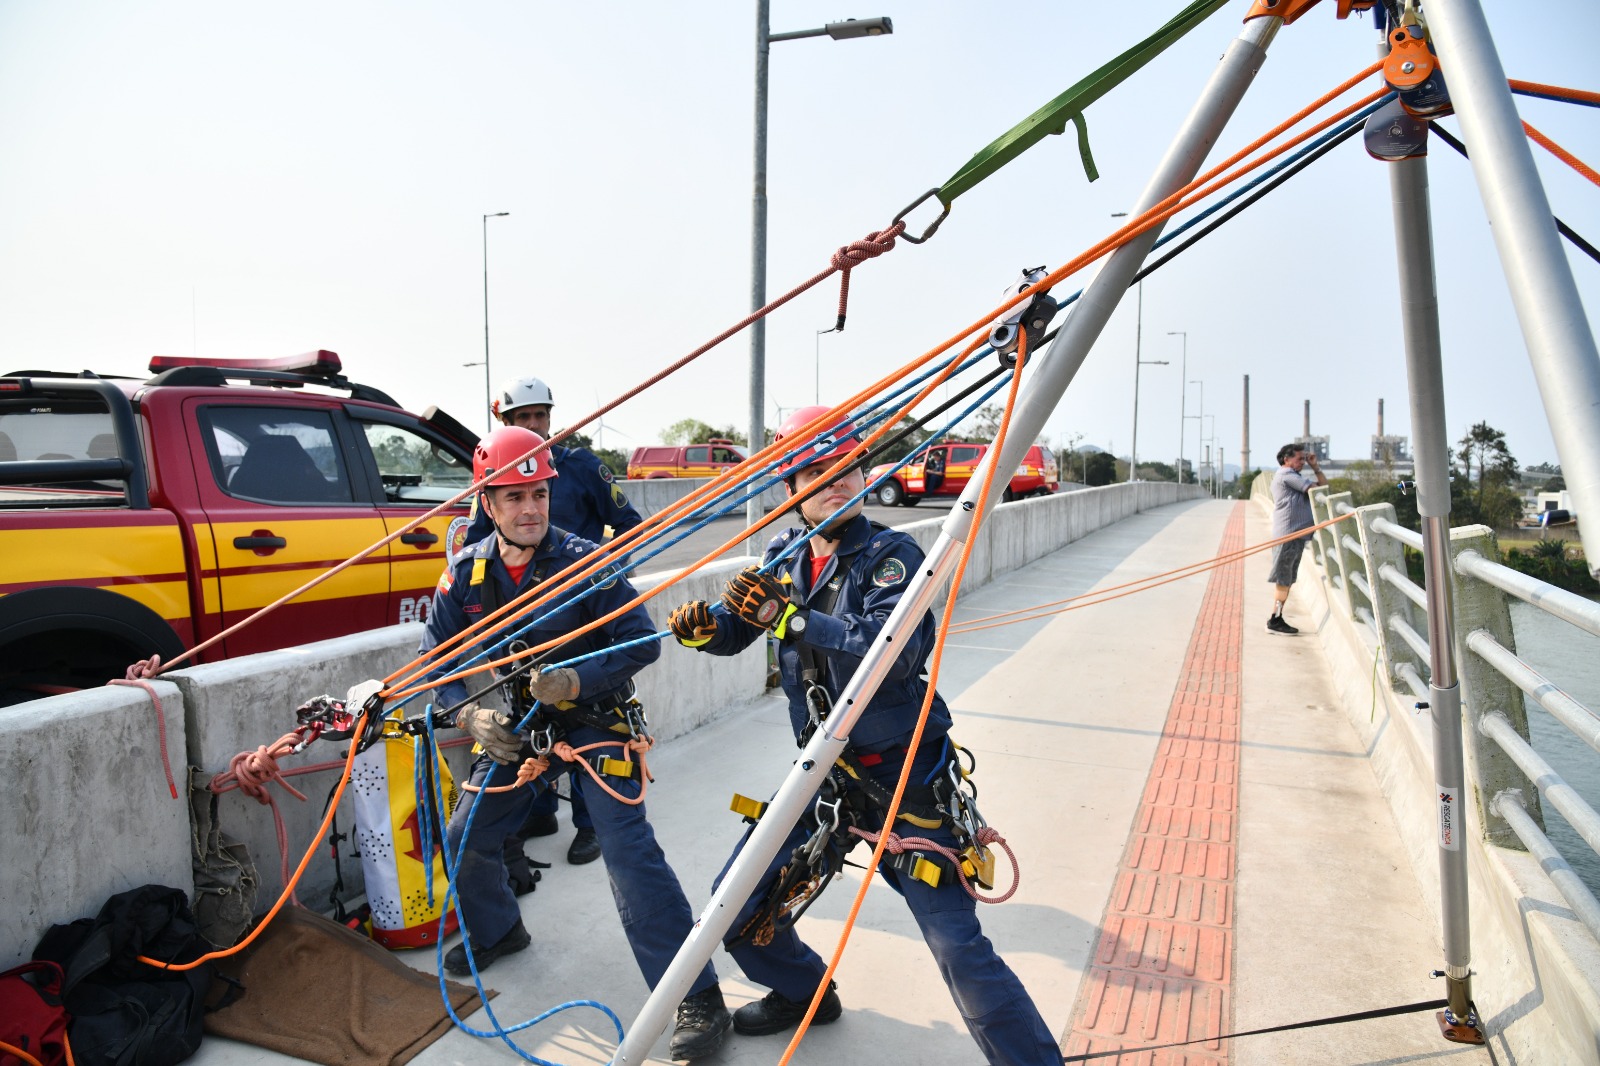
{"left": 0, "top": 682, "right": 194, "bottom": 970}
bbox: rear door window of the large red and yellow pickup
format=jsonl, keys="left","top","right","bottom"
{"left": 205, "top": 407, "right": 355, "bottom": 504}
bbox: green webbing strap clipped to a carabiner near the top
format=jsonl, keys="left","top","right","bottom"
{"left": 939, "top": 0, "right": 1229, "bottom": 208}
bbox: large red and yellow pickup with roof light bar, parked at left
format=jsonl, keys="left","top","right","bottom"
{"left": 0, "top": 351, "right": 477, "bottom": 706}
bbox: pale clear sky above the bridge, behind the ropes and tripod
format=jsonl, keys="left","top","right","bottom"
{"left": 0, "top": 0, "right": 1600, "bottom": 466}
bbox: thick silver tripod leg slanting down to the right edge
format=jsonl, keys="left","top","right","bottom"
{"left": 1427, "top": 0, "right": 1600, "bottom": 573}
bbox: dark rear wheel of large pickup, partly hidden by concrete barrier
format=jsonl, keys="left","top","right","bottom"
{"left": 0, "top": 586, "right": 184, "bottom": 706}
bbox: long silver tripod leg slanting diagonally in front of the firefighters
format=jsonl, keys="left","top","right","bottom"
{"left": 611, "top": 18, "right": 1282, "bottom": 1066}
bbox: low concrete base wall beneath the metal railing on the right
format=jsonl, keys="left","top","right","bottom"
{"left": 1253, "top": 489, "right": 1600, "bottom": 1064}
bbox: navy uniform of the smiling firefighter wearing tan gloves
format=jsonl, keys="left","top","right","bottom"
{"left": 421, "top": 527, "right": 717, "bottom": 992}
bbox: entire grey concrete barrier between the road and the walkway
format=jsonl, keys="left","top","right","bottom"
{"left": 0, "top": 480, "right": 1203, "bottom": 965}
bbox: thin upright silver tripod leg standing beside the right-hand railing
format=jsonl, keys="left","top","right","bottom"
{"left": 1387, "top": 145, "right": 1475, "bottom": 1026}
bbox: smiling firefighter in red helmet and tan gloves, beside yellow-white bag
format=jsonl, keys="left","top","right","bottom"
{"left": 422, "top": 426, "right": 730, "bottom": 1060}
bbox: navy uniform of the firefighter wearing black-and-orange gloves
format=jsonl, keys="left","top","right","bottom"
{"left": 699, "top": 515, "right": 1061, "bottom": 1066}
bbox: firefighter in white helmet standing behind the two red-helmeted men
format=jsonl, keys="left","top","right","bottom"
{"left": 466, "top": 378, "right": 645, "bottom": 866}
